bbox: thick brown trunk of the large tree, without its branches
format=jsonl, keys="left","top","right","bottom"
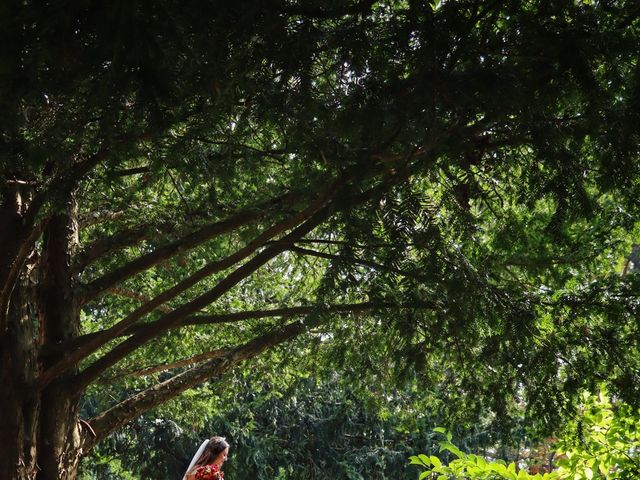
{"left": 0, "top": 188, "right": 82, "bottom": 480}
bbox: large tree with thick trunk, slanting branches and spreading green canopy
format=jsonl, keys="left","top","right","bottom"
{"left": 0, "top": 0, "right": 640, "bottom": 480}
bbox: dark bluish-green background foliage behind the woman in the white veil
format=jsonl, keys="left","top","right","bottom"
{"left": 81, "top": 378, "right": 480, "bottom": 480}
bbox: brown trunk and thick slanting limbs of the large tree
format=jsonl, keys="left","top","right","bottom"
{"left": 0, "top": 157, "right": 412, "bottom": 480}
